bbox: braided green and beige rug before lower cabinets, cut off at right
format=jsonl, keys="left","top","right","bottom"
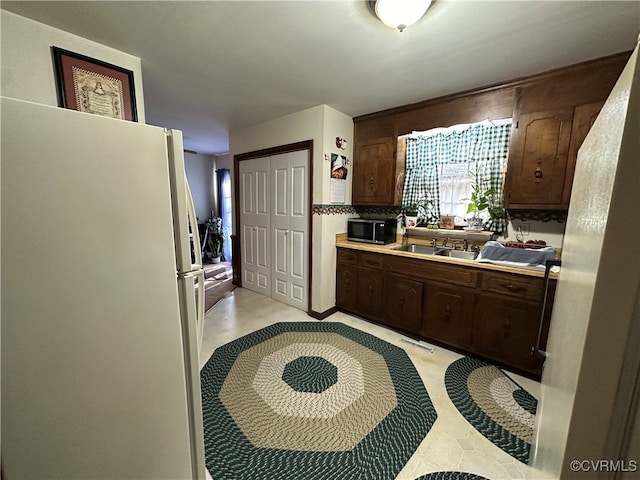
{"left": 444, "top": 357, "right": 538, "bottom": 463}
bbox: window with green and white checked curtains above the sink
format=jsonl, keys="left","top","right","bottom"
{"left": 402, "top": 119, "right": 511, "bottom": 232}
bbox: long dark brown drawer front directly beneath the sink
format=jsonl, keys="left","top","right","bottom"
{"left": 386, "top": 258, "right": 478, "bottom": 288}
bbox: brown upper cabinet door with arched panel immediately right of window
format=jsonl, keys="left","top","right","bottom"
{"left": 505, "top": 108, "right": 573, "bottom": 209}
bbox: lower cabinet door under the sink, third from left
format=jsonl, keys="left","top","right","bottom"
{"left": 383, "top": 274, "right": 424, "bottom": 333}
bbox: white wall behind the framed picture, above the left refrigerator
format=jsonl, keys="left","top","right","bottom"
{"left": 0, "top": 10, "right": 145, "bottom": 123}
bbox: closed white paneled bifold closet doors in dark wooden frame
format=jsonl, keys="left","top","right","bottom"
{"left": 239, "top": 150, "right": 310, "bottom": 311}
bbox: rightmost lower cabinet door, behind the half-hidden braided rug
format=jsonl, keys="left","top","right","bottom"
{"left": 472, "top": 295, "right": 542, "bottom": 376}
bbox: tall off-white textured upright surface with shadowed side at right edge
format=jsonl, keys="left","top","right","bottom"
{"left": 528, "top": 41, "right": 640, "bottom": 480}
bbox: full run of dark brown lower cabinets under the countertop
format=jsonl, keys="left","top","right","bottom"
{"left": 336, "top": 248, "right": 555, "bottom": 379}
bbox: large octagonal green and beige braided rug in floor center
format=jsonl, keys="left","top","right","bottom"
{"left": 201, "top": 322, "right": 437, "bottom": 480}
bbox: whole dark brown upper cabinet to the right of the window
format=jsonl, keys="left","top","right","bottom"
{"left": 505, "top": 54, "right": 628, "bottom": 210}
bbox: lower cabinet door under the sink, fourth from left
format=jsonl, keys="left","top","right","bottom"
{"left": 421, "top": 282, "right": 475, "bottom": 349}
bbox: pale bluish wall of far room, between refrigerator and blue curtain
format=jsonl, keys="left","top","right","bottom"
{"left": 184, "top": 152, "right": 215, "bottom": 223}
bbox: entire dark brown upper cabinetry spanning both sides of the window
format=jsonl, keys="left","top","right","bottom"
{"left": 352, "top": 52, "right": 631, "bottom": 210}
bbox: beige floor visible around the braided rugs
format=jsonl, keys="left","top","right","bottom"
{"left": 200, "top": 288, "right": 539, "bottom": 480}
